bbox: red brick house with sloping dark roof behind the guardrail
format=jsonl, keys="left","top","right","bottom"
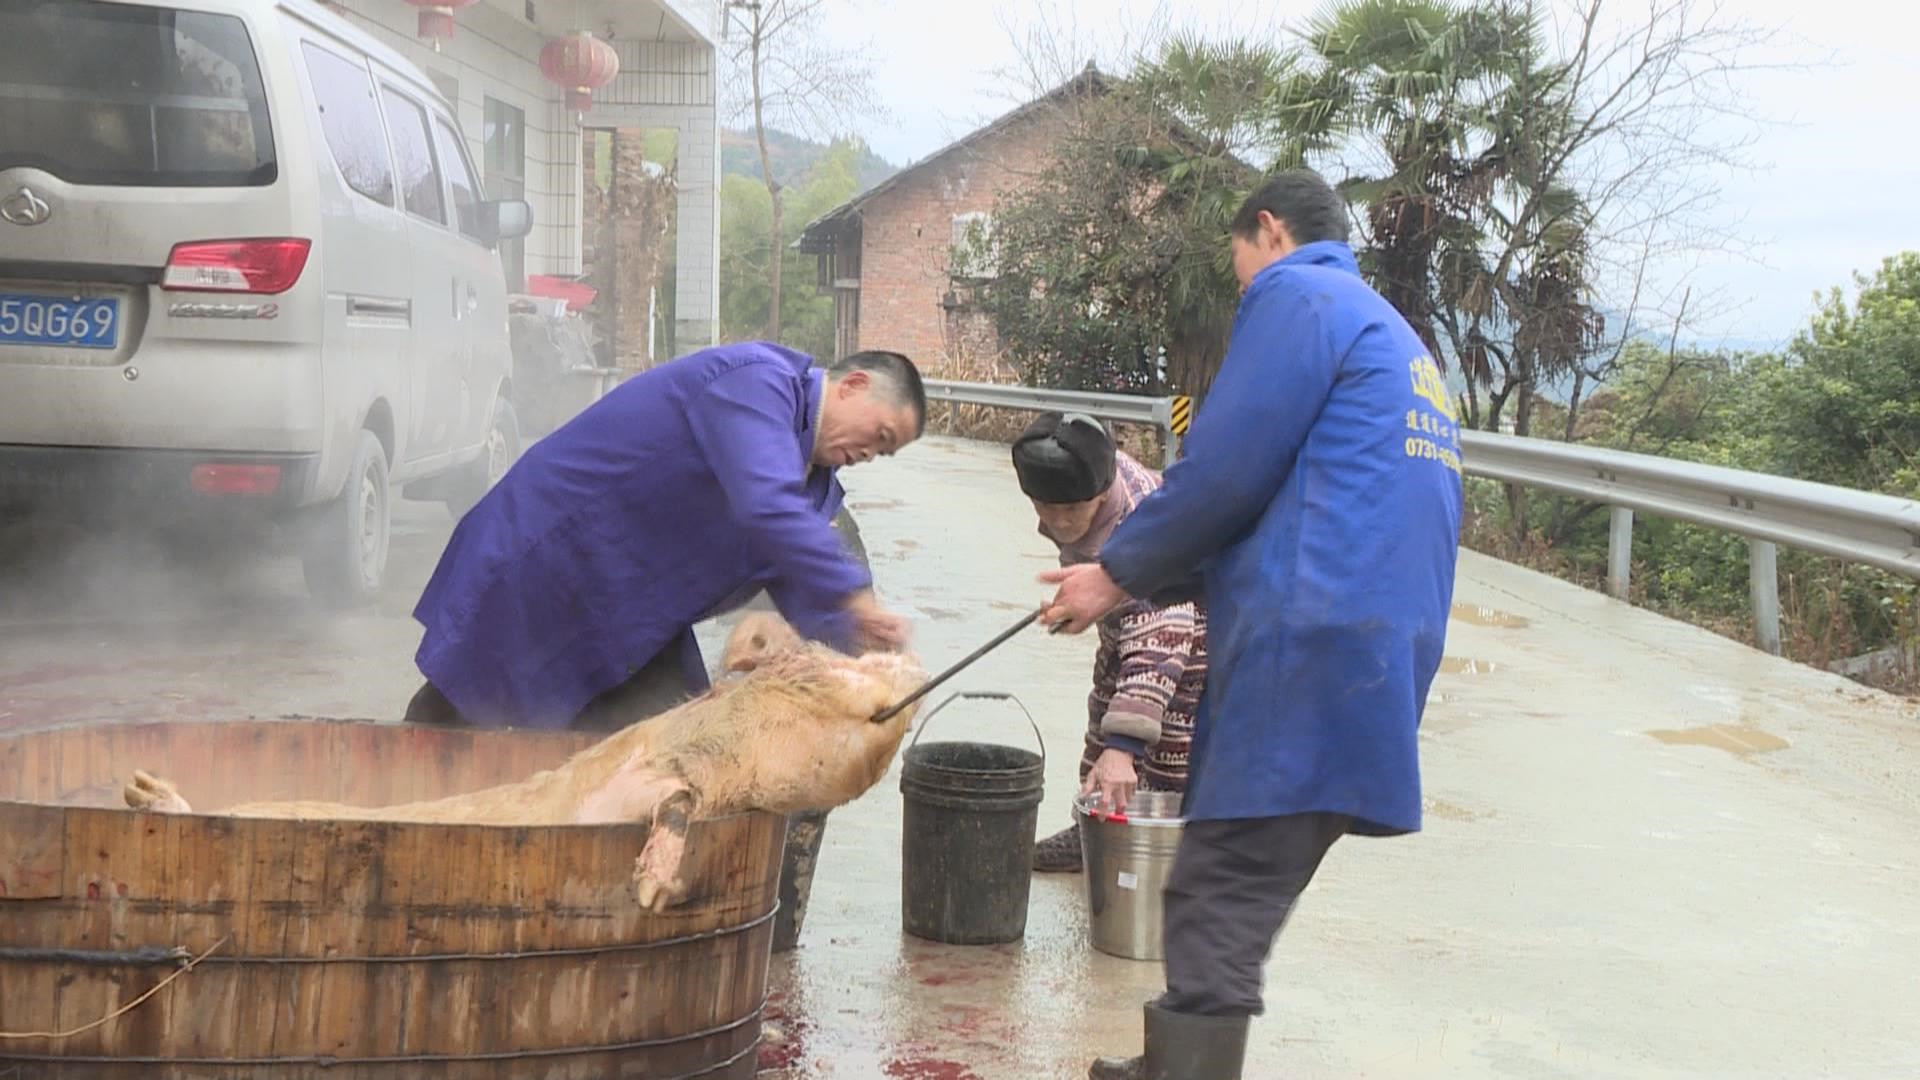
{"left": 795, "top": 65, "right": 1110, "bottom": 371}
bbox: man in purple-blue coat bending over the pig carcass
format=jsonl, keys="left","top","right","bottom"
{"left": 407, "top": 342, "right": 927, "bottom": 730}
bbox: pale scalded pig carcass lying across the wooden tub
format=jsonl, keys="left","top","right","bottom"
{"left": 125, "top": 630, "right": 925, "bottom": 911}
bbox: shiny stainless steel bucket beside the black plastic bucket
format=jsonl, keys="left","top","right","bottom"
{"left": 1073, "top": 792, "right": 1183, "bottom": 961}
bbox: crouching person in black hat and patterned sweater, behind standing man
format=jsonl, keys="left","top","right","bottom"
{"left": 1014, "top": 411, "right": 1206, "bottom": 871}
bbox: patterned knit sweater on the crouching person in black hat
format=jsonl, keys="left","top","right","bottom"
{"left": 1060, "top": 454, "right": 1206, "bottom": 792}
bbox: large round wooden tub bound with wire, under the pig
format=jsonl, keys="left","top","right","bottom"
{"left": 0, "top": 721, "right": 785, "bottom": 1080}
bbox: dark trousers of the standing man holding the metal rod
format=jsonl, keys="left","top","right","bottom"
{"left": 1160, "top": 813, "right": 1354, "bottom": 1017}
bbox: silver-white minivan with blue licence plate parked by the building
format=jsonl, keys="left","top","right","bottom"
{"left": 0, "top": 0, "right": 532, "bottom": 603}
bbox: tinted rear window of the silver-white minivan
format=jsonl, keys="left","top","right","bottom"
{"left": 0, "top": 0, "right": 276, "bottom": 186}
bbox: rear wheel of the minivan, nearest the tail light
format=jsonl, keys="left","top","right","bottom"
{"left": 301, "top": 430, "right": 394, "bottom": 607}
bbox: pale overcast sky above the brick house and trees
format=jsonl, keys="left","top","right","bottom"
{"left": 802, "top": 0, "right": 1920, "bottom": 342}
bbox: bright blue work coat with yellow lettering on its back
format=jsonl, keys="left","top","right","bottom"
{"left": 1100, "top": 242, "right": 1461, "bottom": 836}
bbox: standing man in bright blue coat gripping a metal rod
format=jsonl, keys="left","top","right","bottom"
{"left": 1041, "top": 169, "right": 1461, "bottom": 1080}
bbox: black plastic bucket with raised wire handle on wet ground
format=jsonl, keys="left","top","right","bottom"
{"left": 900, "top": 692, "right": 1046, "bottom": 945}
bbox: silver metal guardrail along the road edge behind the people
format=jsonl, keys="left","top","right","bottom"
{"left": 910, "top": 380, "right": 1920, "bottom": 653}
